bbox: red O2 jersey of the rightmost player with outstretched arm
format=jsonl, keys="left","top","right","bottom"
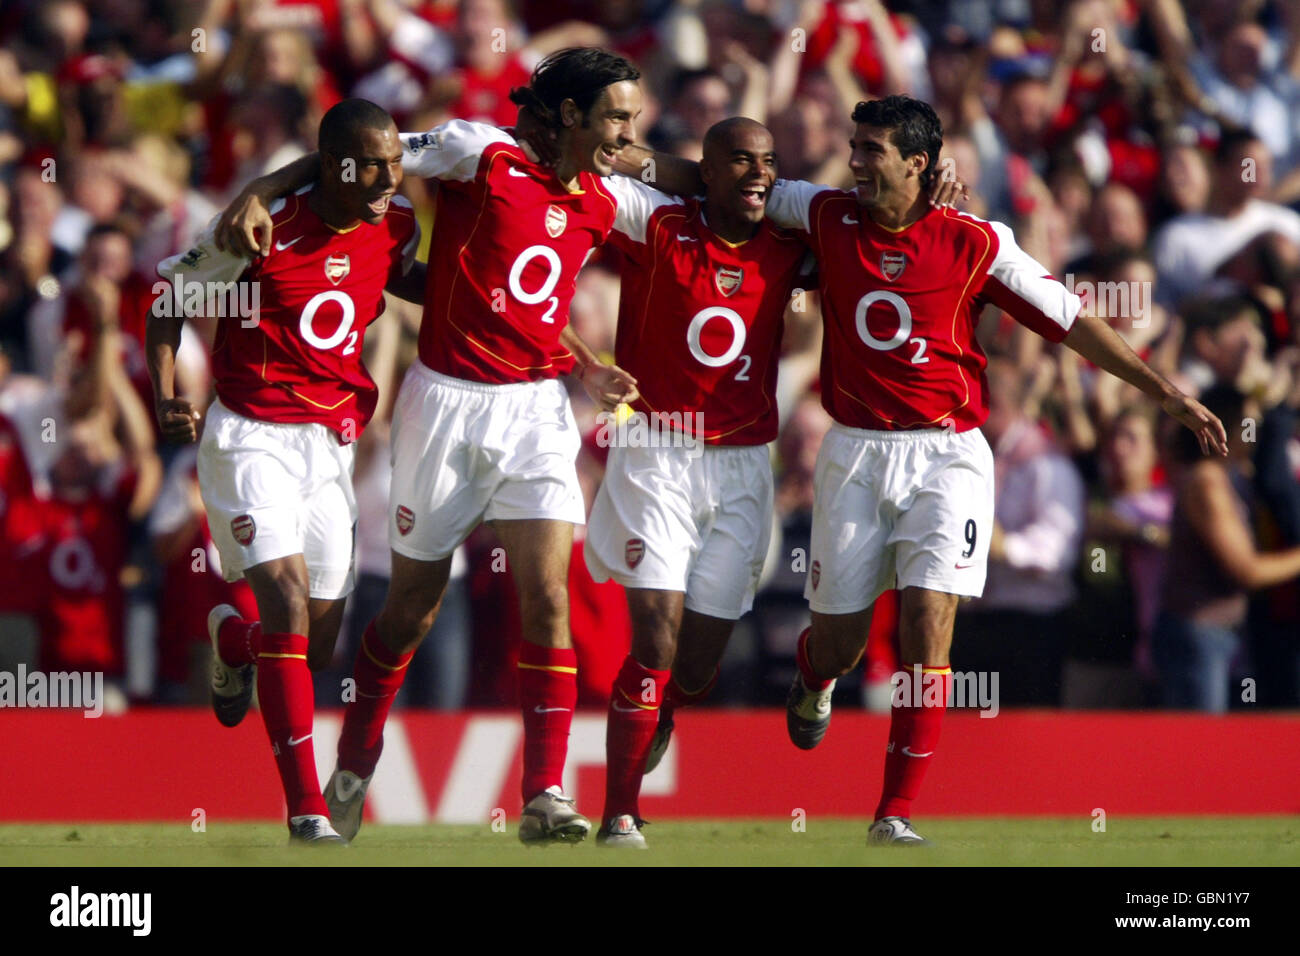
{"left": 767, "top": 181, "right": 1080, "bottom": 432}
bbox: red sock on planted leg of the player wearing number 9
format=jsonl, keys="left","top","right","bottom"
{"left": 876, "top": 665, "right": 953, "bottom": 819}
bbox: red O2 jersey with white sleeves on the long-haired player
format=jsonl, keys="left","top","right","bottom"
{"left": 402, "top": 120, "right": 624, "bottom": 385}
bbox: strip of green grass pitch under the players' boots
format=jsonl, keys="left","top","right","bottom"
{"left": 0, "top": 817, "right": 1300, "bottom": 866}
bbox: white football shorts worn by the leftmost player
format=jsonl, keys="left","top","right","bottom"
{"left": 198, "top": 401, "right": 356, "bottom": 600}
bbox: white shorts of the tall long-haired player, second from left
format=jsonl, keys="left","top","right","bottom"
{"left": 389, "top": 360, "right": 586, "bottom": 561}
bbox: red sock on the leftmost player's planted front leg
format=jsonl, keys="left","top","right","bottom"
{"left": 257, "top": 633, "right": 329, "bottom": 817}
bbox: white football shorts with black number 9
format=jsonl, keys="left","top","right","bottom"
{"left": 803, "top": 424, "right": 993, "bottom": 614}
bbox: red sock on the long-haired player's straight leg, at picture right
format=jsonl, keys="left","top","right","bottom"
{"left": 519, "top": 641, "right": 577, "bottom": 804}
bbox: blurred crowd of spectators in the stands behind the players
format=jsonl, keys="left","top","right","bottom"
{"left": 0, "top": 0, "right": 1300, "bottom": 711}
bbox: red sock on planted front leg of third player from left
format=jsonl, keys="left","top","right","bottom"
{"left": 602, "top": 654, "right": 671, "bottom": 822}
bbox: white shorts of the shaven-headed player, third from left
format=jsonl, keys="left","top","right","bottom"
{"left": 584, "top": 445, "right": 772, "bottom": 620}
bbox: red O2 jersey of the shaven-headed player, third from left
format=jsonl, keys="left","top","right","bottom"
{"left": 610, "top": 187, "right": 811, "bottom": 445}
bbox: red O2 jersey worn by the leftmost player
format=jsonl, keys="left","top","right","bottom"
{"left": 155, "top": 186, "right": 420, "bottom": 442}
